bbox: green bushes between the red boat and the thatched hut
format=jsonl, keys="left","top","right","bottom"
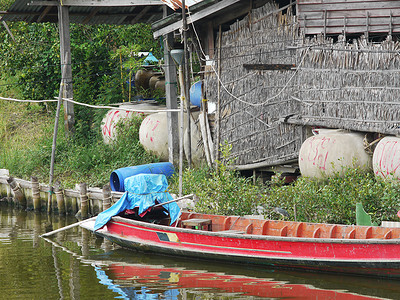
{"left": 171, "top": 142, "right": 400, "bottom": 224}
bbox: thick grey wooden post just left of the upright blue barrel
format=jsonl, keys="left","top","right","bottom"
{"left": 163, "top": 5, "right": 179, "bottom": 163}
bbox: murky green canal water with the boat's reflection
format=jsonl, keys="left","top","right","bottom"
{"left": 0, "top": 204, "right": 400, "bottom": 300}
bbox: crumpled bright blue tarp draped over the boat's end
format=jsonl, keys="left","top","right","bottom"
{"left": 94, "top": 174, "right": 181, "bottom": 231}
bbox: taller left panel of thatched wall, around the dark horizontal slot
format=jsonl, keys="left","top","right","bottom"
{"left": 206, "top": 3, "right": 305, "bottom": 168}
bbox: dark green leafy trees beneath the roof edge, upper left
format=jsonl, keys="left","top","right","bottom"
{"left": 0, "top": 21, "right": 162, "bottom": 144}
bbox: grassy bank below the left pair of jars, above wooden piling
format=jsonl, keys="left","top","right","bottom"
{"left": 0, "top": 103, "right": 157, "bottom": 188}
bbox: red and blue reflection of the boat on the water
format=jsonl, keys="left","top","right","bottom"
{"left": 92, "top": 249, "right": 384, "bottom": 300}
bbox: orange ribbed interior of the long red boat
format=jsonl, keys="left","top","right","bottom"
{"left": 120, "top": 208, "right": 400, "bottom": 240}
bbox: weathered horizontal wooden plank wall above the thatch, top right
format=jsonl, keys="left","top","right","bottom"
{"left": 297, "top": 0, "right": 400, "bottom": 35}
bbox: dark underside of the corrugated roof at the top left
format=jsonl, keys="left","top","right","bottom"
{"left": 2, "top": 0, "right": 163, "bottom": 24}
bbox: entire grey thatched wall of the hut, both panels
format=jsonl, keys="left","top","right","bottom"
{"left": 205, "top": 2, "right": 400, "bottom": 169}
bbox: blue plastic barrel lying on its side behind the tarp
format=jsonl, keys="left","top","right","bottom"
{"left": 110, "top": 162, "right": 175, "bottom": 192}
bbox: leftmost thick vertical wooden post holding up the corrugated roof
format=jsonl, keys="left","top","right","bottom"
{"left": 58, "top": 5, "right": 75, "bottom": 136}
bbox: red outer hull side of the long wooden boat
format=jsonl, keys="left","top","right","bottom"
{"left": 84, "top": 217, "right": 400, "bottom": 277}
